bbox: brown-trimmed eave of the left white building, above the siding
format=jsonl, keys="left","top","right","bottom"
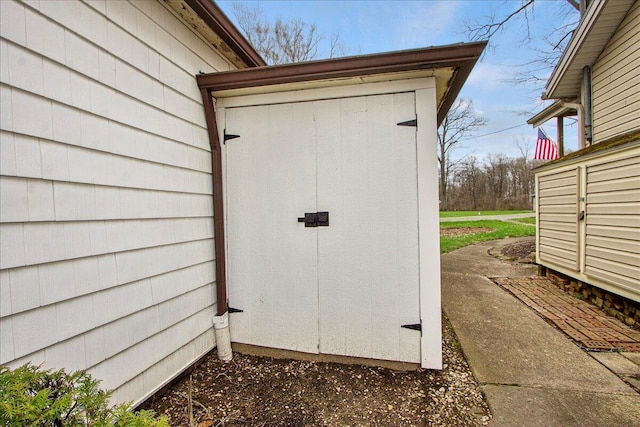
{"left": 164, "top": 0, "right": 267, "bottom": 68}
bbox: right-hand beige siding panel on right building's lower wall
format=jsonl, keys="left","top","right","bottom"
{"left": 585, "top": 154, "right": 640, "bottom": 294}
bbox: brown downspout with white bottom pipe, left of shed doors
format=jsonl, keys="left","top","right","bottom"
{"left": 200, "top": 86, "right": 233, "bottom": 361}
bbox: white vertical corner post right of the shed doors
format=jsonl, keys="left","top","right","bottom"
{"left": 416, "top": 82, "right": 442, "bottom": 369}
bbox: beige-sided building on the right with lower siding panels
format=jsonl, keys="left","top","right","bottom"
{"left": 529, "top": 0, "right": 640, "bottom": 302}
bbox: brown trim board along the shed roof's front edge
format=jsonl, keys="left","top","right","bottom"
{"left": 198, "top": 42, "right": 487, "bottom": 124}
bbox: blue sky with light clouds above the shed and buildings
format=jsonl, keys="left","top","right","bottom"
{"left": 217, "top": 0, "right": 577, "bottom": 160}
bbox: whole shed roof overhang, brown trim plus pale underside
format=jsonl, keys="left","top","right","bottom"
{"left": 198, "top": 42, "right": 486, "bottom": 125}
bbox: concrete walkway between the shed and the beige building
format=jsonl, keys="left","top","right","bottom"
{"left": 441, "top": 239, "right": 640, "bottom": 427}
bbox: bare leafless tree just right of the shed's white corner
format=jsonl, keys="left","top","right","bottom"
{"left": 438, "top": 98, "right": 487, "bottom": 210}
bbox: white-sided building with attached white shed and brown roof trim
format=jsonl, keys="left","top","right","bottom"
{"left": 0, "top": 0, "right": 485, "bottom": 403}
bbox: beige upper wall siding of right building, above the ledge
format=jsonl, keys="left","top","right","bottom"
{"left": 592, "top": 2, "right": 640, "bottom": 143}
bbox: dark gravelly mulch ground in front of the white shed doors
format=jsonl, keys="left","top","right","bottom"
{"left": 141, "top": 316, "right": 491, "bottom": 427}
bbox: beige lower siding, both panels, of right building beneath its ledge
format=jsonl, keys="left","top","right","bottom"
{"left": 536, "top": 140, "right": 640, "bottom": 302}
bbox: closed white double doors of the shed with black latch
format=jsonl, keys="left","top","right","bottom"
{"left": 225, "top": 92, "right": 420, "bottom": 362}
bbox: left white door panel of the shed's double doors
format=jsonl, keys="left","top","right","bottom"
{"left": 226, "top": 104, "right": 318, "bottom": 352}
